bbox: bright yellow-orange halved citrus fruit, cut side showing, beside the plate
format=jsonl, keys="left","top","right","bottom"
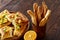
{"left": 24, "top": 30, "right": 37, "bottom": 40}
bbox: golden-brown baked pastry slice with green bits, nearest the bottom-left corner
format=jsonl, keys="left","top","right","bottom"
{"left": 0, "top": 26, "right": 13, "bottom": 40}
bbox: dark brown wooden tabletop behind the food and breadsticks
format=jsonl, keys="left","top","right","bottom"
{"left": 0, "top": 0, "right": 60, "bottom": 40}
